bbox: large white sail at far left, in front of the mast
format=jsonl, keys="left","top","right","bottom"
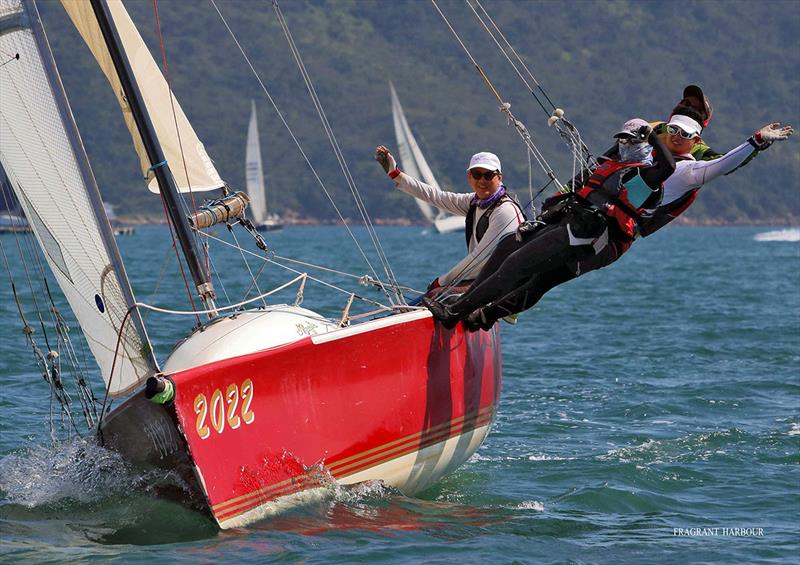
{"left": 0, "top": 0, "right": 156, "bottom": 396}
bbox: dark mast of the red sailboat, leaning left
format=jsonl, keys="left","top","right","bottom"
{"left": 90, "top": 0, "right": 216, "bottom": 318}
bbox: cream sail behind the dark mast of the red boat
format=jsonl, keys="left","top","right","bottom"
{"left": 61, "top": 0, "right": 224, "bottom": 193}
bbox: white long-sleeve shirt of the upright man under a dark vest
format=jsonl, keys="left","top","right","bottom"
{"left": 394, "top": 172, "right": 522, "bottom": 286}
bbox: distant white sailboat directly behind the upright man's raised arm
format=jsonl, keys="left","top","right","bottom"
{"left": 389, "top": 83, "right": 464, "bottom": 233}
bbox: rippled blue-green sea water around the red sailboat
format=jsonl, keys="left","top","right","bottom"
{"left": 0, "top": 227, "right": 800, "bottom": 563}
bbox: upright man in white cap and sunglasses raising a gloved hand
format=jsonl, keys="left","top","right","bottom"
{"left": 375, "top": 145, "right": 525, "bottom": 290}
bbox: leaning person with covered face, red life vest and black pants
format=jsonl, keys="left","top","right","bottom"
{"left": 423, "top": 118, "right": 675, "bottom": 329}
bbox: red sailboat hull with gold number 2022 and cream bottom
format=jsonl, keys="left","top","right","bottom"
{"left": 170, "top": 312, "right": 501, "bottom": 527}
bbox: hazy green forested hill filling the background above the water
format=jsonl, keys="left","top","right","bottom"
{"left": 34, "top": 0, "right": 800, "bottom": 223}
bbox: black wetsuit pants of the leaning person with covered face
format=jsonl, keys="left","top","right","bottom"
{"left": 448, "top": 206, "right": 608, "bottom": 319}
